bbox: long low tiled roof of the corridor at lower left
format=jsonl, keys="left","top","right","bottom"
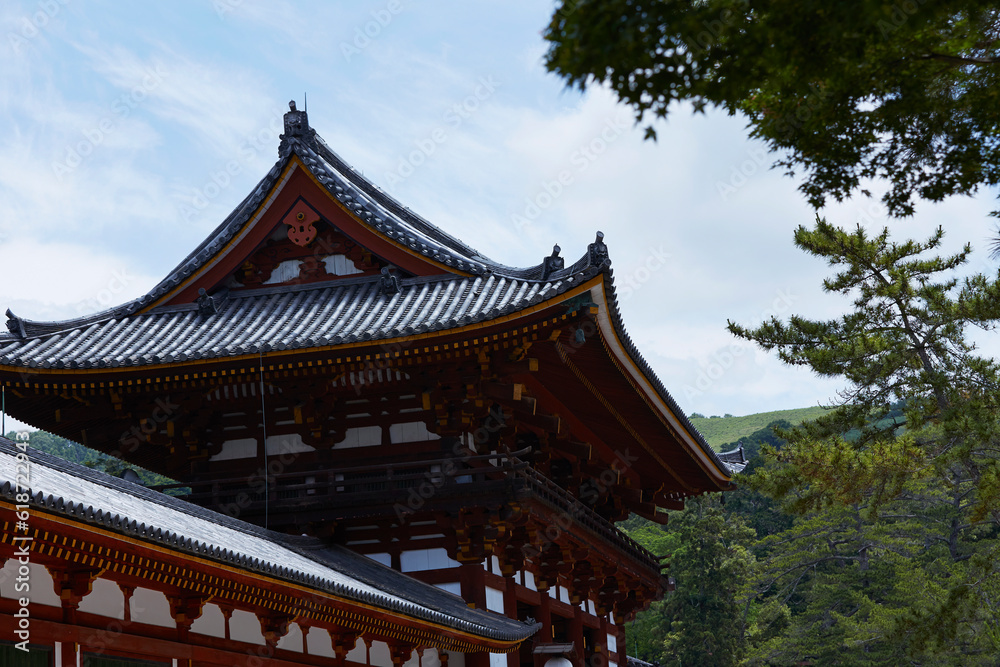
{"left": 0, "top": 437, "right": 539, "bottom": 642}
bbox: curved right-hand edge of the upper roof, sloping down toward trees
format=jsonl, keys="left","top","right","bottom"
{"left": 594, "top": 271, "right": 732, "bottom": 491}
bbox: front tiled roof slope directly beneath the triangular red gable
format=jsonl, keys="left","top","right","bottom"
{"left": 0, "top": 272, "right": 596, "bottom": 369}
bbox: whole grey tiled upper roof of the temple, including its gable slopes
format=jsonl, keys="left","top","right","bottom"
{"left": 0, "top": 106, "right": 734, "bottom": 478}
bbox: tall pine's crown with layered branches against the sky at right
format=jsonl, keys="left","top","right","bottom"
{"left": 729, "top": 220, "right": 1000, "bottom": 518}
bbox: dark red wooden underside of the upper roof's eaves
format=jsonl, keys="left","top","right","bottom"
{"left": 6, "top": 300, "right": 728, "bottom": 498}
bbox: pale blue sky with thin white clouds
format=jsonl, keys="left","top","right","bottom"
{"left": 0, "top": 0, "right": 995, "bottom": 434}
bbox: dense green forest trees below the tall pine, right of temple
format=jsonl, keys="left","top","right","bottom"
{"left": 620, "top": 408, "right": 1000, "bottom": 666}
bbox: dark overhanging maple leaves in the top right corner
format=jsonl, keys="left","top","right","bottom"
{"left": 545, "top": 0, "right": 1000, "bottom": 216}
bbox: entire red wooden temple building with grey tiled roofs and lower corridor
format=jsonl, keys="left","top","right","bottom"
{"left": 0, "top": 103, "right": 742, "bottom": 667}
